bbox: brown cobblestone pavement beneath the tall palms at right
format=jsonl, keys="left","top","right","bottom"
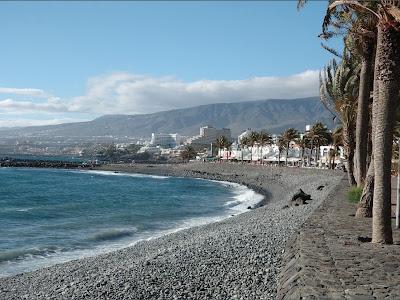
{"left": 277, "top": 181, "right": 400, "bottom": 299}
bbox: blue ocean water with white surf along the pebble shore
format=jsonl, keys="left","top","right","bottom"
{"left": 0, "top": 168, "right": 262, "bottom": 277}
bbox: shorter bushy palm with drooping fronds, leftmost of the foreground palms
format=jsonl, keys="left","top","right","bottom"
{"left": 320, "top": 54, "right": 358, "bottom": 186}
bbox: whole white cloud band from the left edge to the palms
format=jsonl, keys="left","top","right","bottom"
{"left": 0, "top": 70, "right": 319, "bottom": 127}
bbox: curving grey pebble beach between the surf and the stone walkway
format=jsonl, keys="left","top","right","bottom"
{"left": 0, "top": 163, "right": 344, "bottom": 299}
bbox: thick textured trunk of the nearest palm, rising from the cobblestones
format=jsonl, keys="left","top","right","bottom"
{"left": 372, "top": 21, "right": 400, "bottom": 244}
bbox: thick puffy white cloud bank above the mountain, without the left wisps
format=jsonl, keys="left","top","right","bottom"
{"left": 70, "top": 71, "right": 319, "bottom": 114}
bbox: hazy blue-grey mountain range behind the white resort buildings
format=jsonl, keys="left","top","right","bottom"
{"left": 0, "top": 97, "right": 333, "bottom": 138}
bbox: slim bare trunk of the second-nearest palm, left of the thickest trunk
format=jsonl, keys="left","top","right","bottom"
{"left": 355, "top": 38, "right": 374, "bottom": 186}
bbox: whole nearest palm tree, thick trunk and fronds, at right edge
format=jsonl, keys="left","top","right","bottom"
{"left": 330, "top": 0, "right": 400, "bottom": 244}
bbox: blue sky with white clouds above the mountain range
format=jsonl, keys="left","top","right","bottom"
{"left": 0, "top": 1, "right": 335, "bottom": 127}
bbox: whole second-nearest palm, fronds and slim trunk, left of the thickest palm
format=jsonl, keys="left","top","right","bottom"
{"left": 320, "top": 0, "right": 378, "bottom": 186}
